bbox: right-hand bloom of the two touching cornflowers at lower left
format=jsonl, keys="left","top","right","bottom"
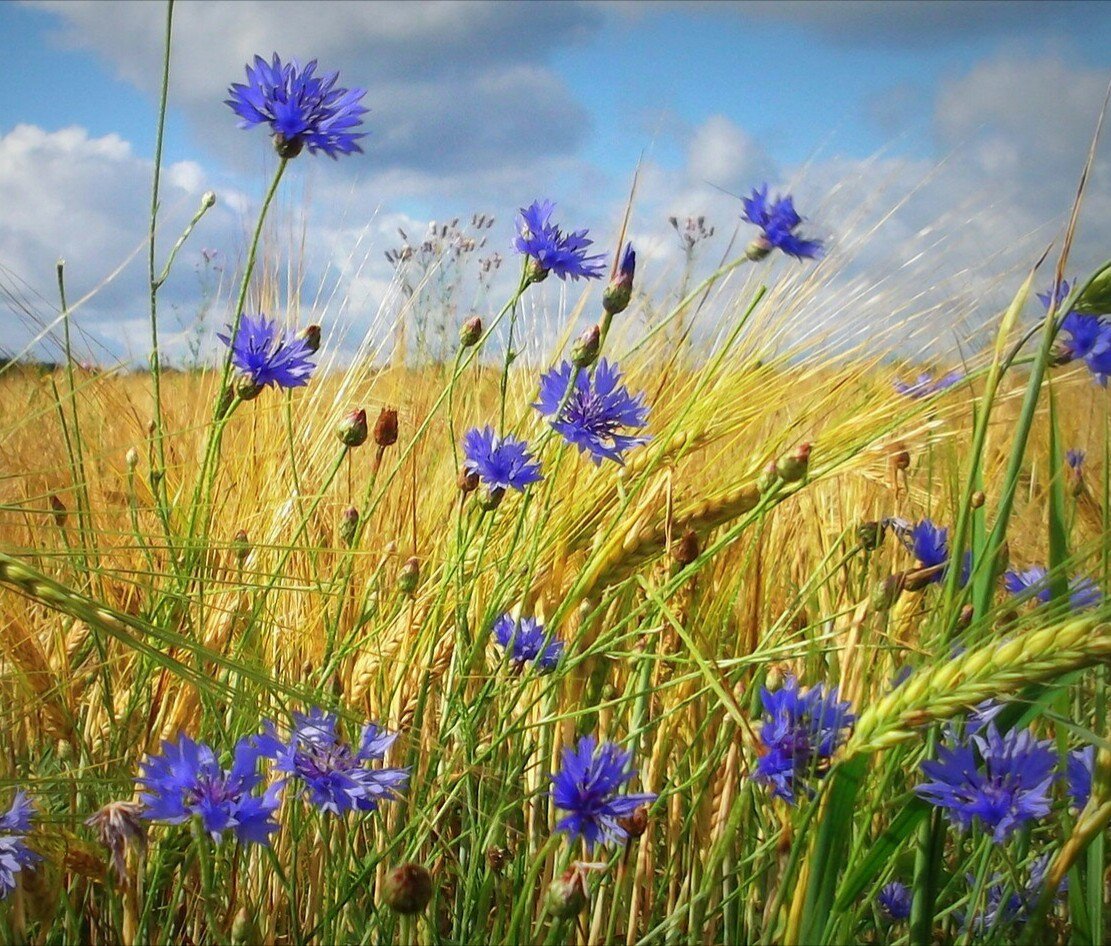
{"left": 262, "top": 707, "right": 409, "bottom": 815}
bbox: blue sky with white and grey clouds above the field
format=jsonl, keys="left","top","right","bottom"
{"left": 0, "top": 0, "right": 1111, "bottom": 360}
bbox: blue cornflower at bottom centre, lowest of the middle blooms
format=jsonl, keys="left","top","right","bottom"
{"left": 551, "top": 736, "right": 657, "bottom": 849}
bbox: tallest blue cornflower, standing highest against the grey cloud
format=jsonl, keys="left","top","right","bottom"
{"left": 224, "top": 52, "right": 367, "bottom": 159}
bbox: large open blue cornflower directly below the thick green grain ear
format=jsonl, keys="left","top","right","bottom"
{"left": 915, "top": 724, "right": 1057, "bottom": 844}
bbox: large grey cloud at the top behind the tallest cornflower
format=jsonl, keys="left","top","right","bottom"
{"left": 40, "top": 0, "right": 601, "bottom": 173}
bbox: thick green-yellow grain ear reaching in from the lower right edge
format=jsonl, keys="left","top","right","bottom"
{"left": 845, "top": 617, "right": 1111, "bottom": 758}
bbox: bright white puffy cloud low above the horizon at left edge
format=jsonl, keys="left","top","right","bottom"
{"left": 0, "top": 125, "right": 245, "bottom": 356}
